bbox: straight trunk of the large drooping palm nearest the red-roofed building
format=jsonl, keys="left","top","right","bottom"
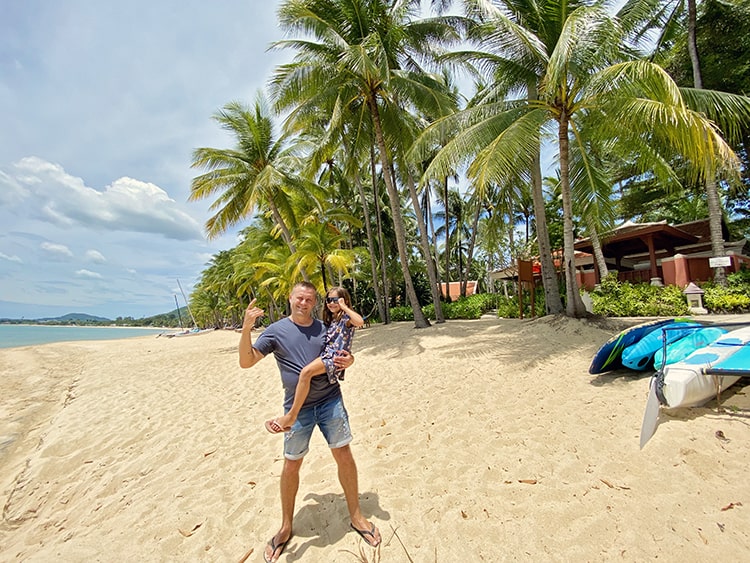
{"left": 557, "top": 112, "right": 586, "bottom": 318}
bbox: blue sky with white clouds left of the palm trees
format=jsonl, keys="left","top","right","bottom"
{"left": 0, "top": 0, "right": 287, "bottom": 318}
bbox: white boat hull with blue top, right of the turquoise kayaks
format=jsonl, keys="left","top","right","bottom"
{"left": 656, "top": 327, "right": 750, "bottom": 408}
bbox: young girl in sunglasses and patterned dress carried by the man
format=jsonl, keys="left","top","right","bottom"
{"left": 265, "top": 287, "right": 365, "bottom": 434}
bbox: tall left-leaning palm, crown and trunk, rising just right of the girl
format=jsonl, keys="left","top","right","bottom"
{"left": 272, "top": 0, "right": 468, "bottom": 328}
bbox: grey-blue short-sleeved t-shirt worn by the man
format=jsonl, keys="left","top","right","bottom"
{"left": 253, "top": 317, "right": 341, "bottom": 410}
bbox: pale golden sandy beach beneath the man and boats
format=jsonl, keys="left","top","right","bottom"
{"left": 0, "top": 317, "right": 750, "bottom": 563}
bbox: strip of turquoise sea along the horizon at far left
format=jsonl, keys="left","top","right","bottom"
{"left": 0, "top": 324, "right": 174, "bottom": 348}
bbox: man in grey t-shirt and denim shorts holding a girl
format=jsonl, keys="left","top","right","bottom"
{"left": 239, "top": 282, "right": 381, "bottom": 563}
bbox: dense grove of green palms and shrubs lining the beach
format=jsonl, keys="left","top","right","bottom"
{"left": 190, "top": 0, "right": 750, "bottom": 327}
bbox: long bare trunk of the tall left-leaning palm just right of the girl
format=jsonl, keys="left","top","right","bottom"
{"left": 367, "top": 96, "right": 430, "bottom": 328}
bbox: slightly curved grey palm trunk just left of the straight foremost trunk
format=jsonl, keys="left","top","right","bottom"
{"left": 528, "top": 82, "right": 563, "bottom": 315}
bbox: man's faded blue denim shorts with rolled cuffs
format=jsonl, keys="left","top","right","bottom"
{"left": 284, "top": 395, "right": 352, "bottom": 460}
